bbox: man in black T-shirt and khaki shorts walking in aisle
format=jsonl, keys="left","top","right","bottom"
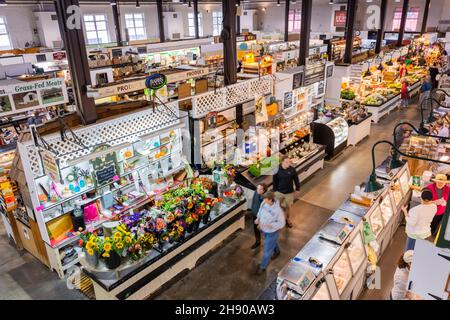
{"left": 272, "top": 156, "right": 300, "bottom": 228}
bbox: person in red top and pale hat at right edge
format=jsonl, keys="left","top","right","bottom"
{"left": 427, "top": 173, "right": 450, "bottom": 236}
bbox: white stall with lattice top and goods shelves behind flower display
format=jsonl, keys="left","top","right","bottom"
{"left": 13, "top": 101, "right": 185, "bottom": 277}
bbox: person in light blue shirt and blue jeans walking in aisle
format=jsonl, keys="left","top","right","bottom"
{"left": 255, "top": 191, "right": 286, "bottom": 274}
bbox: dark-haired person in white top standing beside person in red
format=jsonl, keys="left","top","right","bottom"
{"left": 402, "top": 189, "right": 437, "bottom": 250}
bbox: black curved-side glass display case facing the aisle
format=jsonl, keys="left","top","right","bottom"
{"left": 312, "top": 117, "right": 349, "bottom": 160}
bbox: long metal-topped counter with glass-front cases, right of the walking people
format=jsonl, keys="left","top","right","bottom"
{"left": 277, "top": 159, "right": 411, "bottom": 300}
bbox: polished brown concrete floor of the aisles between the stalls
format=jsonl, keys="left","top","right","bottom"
{"left": 0, "top": 105, "right": 419, "bottom": 300}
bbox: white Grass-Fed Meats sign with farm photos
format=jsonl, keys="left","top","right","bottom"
{"left": 0, "top": 78, "right": 69, "bottom": 115}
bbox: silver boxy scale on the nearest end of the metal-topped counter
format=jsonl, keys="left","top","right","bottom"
{"left": 278, "top": 260, "right": 316, "bottom": 295}
